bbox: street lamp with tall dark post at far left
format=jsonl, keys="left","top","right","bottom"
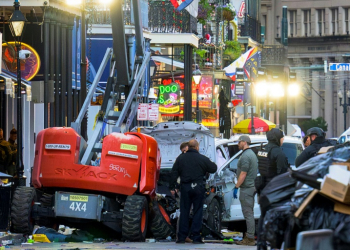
{"left": 9, "top": 0, "right": 27, "bottom": 186}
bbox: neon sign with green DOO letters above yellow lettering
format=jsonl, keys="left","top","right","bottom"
{"left": 158, "top": 82, "right": 180, "bottom": 114}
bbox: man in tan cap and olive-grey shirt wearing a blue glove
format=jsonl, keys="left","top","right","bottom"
{"left": 233, "top": 135, "right": 258, "bottom": 246}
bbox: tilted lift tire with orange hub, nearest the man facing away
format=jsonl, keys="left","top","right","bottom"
{"left": 150, "top": 200, "right": 175, "bottom": 239}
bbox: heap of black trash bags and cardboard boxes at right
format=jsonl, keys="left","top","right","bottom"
{"left": 259, "top": 143, "right": 350, "bottom": 249}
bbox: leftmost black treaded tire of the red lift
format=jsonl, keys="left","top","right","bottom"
{"left": 11, "top": 187, "right": 36, "bottom": 234}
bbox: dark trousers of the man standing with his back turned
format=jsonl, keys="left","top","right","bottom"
{"left": 177, "top": 183, "right": 205, "bottom": 241}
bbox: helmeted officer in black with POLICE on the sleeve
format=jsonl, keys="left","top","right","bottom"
{"left": 255, "top": 128, "right": 288, "bottom": 250}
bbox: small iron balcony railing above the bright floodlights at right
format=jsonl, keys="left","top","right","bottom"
{"left": 261, "top": 45, "right": 285, "bottom": 66}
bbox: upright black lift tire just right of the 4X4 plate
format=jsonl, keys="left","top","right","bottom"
{"left": 122, "top": 195, "right": 148, "bottom": 241}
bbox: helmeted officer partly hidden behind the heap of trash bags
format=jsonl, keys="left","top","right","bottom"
{"left": 295, "top": 127, "right": 333, "bottom": 167}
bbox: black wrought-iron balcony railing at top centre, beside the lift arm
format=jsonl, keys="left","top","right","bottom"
{"left": 148, "top": 0, "right": 197, "bottom": 34}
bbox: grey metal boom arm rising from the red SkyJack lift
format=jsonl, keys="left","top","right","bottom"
{"left": 71, "top": 0, "right": 151, "bottom": 165}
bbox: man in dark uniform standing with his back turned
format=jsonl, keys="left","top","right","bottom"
{"left": 171, "top": 139, "right": 217, "bottom": 244}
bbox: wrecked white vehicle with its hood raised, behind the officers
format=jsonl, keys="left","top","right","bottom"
{"left": 135, "top": 121, "right": 304, "bottom": 234}
